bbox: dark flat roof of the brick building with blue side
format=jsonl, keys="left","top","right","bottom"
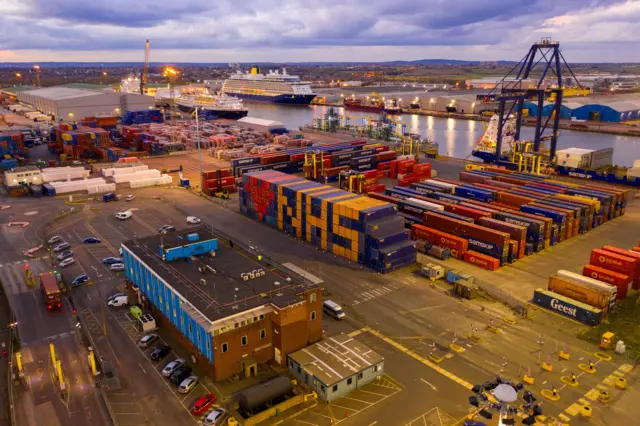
{"left": 122, "top": 225, "right": 317, "bottom": 327}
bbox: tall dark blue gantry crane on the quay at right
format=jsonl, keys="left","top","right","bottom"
{"left": 478, "top": 37, "right": 582, "bottom": 162}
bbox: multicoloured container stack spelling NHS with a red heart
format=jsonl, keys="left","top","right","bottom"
{"left": 239, "top": 171, "right": 416, "bottom": 273}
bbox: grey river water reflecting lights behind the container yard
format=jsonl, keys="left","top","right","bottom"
{"left": 246, "top": 102, "right": 640, "bottom": 167}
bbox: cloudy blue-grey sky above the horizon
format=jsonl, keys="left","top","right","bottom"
{"left": 0, "top": 0, "right": 640, "bottom": 62}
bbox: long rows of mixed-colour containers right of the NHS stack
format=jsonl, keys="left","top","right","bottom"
{"left": 369, "top": 167, "right": 629, "bottom": 270}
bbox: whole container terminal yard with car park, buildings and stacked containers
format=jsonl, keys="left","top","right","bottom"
{"left": 0, "top": 42, "right": 640, "bottom": 426}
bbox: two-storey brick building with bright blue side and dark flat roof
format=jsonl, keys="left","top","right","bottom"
{"left": 122, "top": 225, "right": 322, "bottom": 380}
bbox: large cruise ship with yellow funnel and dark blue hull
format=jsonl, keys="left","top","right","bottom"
{"left": 221, "top": 67, "right": 316, "bottom": 105}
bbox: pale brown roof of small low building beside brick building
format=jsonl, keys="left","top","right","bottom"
{"left": 289, "top": 334, "right": 384, "bottom": 386}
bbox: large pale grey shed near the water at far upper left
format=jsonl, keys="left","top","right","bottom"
{"left": 17, "top": 86, "right": 155, "bottom": 121}
